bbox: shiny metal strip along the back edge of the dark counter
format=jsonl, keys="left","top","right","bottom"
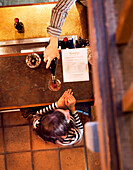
{"left": 0, "top": 35, "right": 77, "bottom": 55}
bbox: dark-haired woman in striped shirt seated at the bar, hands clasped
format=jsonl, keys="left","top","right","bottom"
{"left": 23, "top": 89, "right": 83, "bottom": 145}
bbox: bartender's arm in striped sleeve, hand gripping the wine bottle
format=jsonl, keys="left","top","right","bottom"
{"left": 44, "top": 0, "right": 76, "bottom": 68}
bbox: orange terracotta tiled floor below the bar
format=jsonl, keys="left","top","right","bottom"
{"left": 0, "top": 105, "right": 100, "bottom": 170}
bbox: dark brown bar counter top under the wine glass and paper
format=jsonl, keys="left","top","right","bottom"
{"left": 0, "top": 53, "right": 93, "bottom": 110}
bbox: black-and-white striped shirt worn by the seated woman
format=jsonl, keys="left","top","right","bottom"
{"left": 33, "top": 103, "right": 83, "bottom": 145}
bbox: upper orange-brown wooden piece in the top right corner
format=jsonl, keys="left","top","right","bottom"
{"left": 116, "top": 0, "right": 133, "bottom": 44}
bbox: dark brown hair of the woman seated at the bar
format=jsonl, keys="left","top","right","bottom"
{"left": 36, "top": 110, "right": 71, "bottom": 143}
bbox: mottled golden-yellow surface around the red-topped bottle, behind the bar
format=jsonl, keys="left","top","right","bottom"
{"left": 0, "top": 3, "right": 86, "bottom": 41}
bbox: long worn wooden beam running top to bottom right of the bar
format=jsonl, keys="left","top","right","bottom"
{"left": 88, "top": 0, "right": 123, "bottom": 170}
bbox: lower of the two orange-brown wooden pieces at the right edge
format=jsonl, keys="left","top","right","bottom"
{"left": 122, "top": 83, "right": 133, "bottom": 112}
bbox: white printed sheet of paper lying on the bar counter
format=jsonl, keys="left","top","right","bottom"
{"left": 62, "top": 48, "right": 89, "bottom": 82}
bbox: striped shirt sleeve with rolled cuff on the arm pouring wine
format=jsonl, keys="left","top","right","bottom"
{"left": 47, "top": 0, "right": 87, "bottom": 37}
